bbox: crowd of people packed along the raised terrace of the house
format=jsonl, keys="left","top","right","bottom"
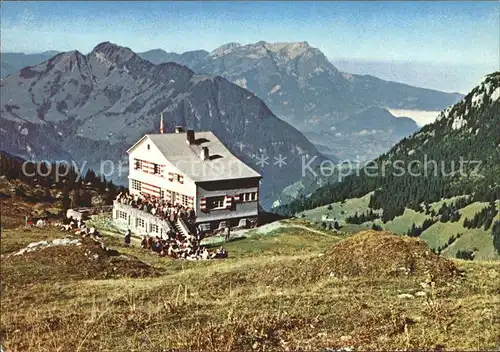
{"left": 116, "top": 192, "right": 195, "bottom": 222}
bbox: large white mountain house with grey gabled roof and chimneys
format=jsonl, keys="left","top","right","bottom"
{"left": 113, "top": 127, "right": 261, "bottom": 234}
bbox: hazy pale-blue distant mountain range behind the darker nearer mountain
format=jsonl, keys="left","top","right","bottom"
{"left": 2, "top": 41, "right": 463, "bottom": 161}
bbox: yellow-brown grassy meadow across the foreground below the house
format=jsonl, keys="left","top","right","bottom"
{"left": 0, "top": 223, "right": 500, "bottom": 351}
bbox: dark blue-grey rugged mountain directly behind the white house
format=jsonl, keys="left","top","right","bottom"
{"left": 0, "top": 43, "right": 324, "bottom": 207}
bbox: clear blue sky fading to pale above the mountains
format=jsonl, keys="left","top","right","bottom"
{"left": 1, "top": 1, "right": 500, "bottom": 92}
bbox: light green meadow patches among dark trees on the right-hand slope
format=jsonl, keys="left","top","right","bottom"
{"left": 298, "top": 193, "right": 500, "bottom": 260}
